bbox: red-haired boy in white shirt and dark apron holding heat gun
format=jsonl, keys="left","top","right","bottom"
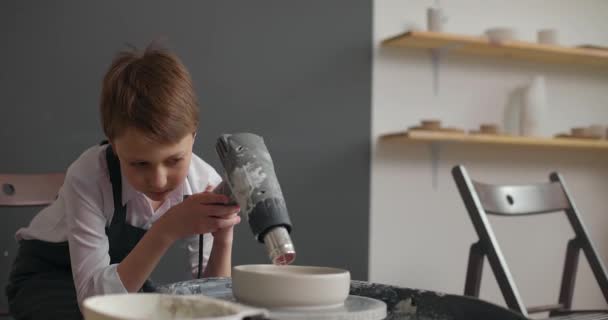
{"left": 6, "top": 45, "right": 240, "bottom": 319}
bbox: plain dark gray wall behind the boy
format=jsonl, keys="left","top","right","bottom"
{"left": 0, "top": 0, "right": 372, "bottom": 310}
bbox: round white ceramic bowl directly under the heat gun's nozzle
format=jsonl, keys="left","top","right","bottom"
{"left": 232, "top": 264, "right": 350, "bottom": 308}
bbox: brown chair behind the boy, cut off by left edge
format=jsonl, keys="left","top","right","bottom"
{"left": 0, "top": 173, "right": 65, "bottom": 317}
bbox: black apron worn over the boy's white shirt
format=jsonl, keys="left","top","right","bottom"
{"left": 6, "top": 146, "right": 154, "bottom": 320}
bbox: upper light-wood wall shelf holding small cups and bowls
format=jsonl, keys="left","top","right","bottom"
{"left": 382, "top": 31, "right": 608, "bottom": 67}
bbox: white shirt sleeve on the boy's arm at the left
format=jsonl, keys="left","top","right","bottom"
{"left": 64, "top": 171, "right": 127, "bottom": 304}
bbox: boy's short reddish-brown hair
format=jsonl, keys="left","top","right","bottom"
{"left": 100, "top": 47, "right": 198, "bottom": 143}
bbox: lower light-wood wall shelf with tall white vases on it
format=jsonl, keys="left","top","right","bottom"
{"left": 380, "top": 130, "right": 608, "bottom": 150}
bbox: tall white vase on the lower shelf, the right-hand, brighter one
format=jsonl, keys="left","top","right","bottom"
{"left": 520, "top": 76, "right": 547, "bottom": 137}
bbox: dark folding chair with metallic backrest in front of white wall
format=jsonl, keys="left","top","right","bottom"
{"left": 452, "top": 166, "right": 608, "bottom": 320}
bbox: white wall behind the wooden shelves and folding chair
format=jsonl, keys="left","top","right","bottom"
{"left": 369, "top": 0, "right": 608, "bottom": 307}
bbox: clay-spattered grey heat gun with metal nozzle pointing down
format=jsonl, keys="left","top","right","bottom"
{"left": 203, "top": 133, "right": 296, "bottom": 264}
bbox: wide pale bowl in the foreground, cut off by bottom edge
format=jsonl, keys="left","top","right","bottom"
{"left": 82, "top": 293, "right": 267, "bottom": 320}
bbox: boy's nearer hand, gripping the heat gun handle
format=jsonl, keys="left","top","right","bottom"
{"left": 154, "top": 189, "right": 241, "bottom": 242}
